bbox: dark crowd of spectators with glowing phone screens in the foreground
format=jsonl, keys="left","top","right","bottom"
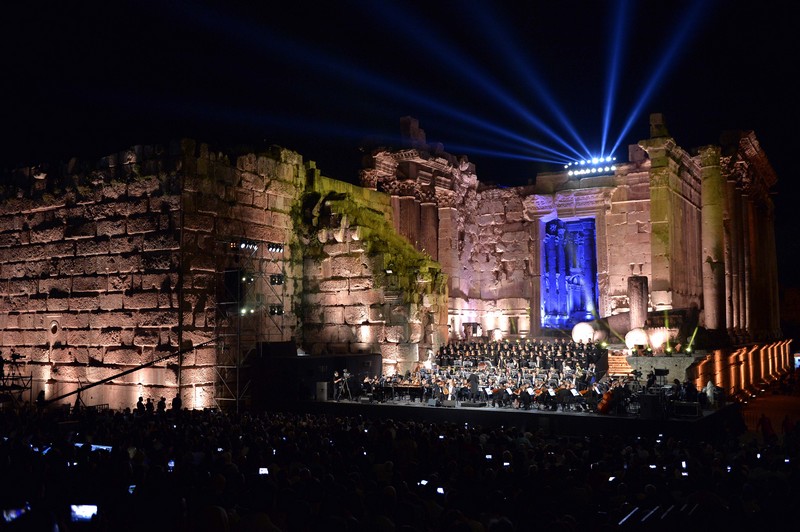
{"left": 0, "top": 368, "right": 800, "bottom": 532}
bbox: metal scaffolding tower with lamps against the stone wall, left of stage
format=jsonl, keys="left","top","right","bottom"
{"left": 214, "top": 239, "right": 290, "bottom": 413}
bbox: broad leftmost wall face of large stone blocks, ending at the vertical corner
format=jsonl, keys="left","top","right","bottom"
{"left": 0, "top": 143, "right": 186, "bottom": 406}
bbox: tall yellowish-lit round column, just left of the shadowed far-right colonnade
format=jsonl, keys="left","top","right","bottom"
{"left": 700, "top": 146, "right": 725, "bottom": 330}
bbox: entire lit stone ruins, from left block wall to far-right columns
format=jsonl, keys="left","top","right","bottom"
{"left": 0, "top": 115, "right": 780, "bottom": 408}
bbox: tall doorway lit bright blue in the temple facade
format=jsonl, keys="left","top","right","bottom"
{"left": 541, "top": 218, "right": 598, "bottom": 330}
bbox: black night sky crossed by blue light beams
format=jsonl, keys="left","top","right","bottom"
{"left": 0, "top": 0, "right": 800, "bottom": 286}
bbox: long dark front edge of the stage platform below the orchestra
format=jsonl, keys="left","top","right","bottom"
{"left": 276, "top": 396, "right": 742, "bottom": 441}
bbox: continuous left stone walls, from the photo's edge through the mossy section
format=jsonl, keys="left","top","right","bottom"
{"left": 0, "top": 140, "right": 446, "bottom": 408}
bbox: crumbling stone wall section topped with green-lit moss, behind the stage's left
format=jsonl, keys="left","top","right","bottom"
{"left": 298, "top": 178, "right": 447, "bottom": 373}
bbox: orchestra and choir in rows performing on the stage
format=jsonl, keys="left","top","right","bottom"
{"left": 340, "top": 338, "right": 648, "bottom": 413}
